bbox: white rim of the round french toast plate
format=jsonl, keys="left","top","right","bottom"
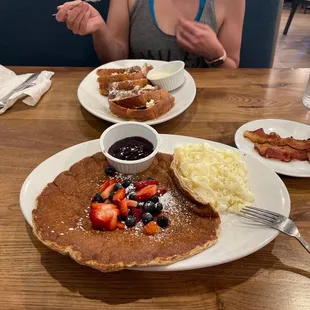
{"left": 77, "top": 59, "right": 197, "bottom": 126}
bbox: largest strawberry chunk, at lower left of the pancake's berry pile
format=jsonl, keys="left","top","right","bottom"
{"left": 89, "top": 203, "right": 120, "bottom": 230}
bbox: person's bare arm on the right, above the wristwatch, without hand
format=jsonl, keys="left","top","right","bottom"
{"left": 218, "top": 0, "right": 245, "bottom": 68}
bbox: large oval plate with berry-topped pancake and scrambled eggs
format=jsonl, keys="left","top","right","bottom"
{"left": 20, "top": 122, "right": 290, "bottom": 272}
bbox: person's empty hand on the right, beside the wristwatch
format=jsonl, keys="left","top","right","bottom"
{"left": 176, "top": 19, "right": 224, "bottom": 61}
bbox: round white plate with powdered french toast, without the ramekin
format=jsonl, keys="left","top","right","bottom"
{"left": 78, "top": 60, "right": 196, "bottom": 125}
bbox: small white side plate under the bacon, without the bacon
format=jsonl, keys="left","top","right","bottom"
{"left": 235, "top": 119, "right": 310, "bottom": 177}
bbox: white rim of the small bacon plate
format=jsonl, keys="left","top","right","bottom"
{"left": 234, "top": 119, "right": 310, "bottom": 178}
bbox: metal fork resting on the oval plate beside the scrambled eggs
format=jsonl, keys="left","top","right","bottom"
{"left": 239, "top": 207, "right": 310, "bottom": 253}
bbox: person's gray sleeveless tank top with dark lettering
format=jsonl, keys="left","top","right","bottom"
{"left": 129, "top": 0, "right": 218, "bottom": 68}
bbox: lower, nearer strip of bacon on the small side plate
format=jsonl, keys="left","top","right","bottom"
{"left": 254, "top": 143, "right": 310, "bottom": 162}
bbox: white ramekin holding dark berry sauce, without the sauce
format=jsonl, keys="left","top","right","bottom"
{"left": 100, "top": 122, "right": 160, "bottom": 174}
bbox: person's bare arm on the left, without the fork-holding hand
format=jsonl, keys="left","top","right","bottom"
{"left": 93, "top": 0, "right": 129, "bottom": 63}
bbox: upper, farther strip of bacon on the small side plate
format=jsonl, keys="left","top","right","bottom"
{"left": 243, "top": 128, "right": 310, "bottom": 150}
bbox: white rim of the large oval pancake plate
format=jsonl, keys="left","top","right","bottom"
{"left": 20, "top": 134, "right": 291, "bottom": 272}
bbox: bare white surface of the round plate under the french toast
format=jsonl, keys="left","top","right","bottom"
{"left": 77, "top": 59, "right": 196, "bottom": 125}
